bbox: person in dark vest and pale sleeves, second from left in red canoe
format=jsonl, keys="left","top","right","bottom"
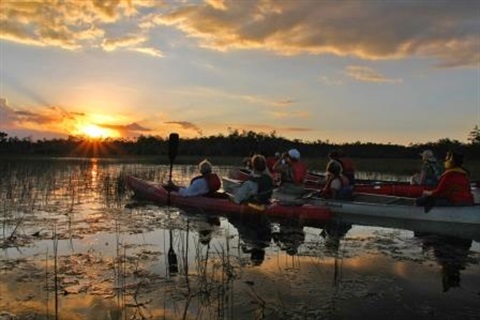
{"left": 232, "top": 155, "right": 274, "bottom": 204}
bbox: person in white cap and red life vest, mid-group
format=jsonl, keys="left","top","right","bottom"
{"left": 273, "top": 149, "right": 307, "bottom": 197}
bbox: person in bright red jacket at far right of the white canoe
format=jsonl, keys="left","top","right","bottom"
{"left": 416, "top": 151, "right": 474, "bottom": 211}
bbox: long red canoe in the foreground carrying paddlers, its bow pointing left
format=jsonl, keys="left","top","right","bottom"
{"left": 125, "top": 176, "right": 332, "bottom": 221}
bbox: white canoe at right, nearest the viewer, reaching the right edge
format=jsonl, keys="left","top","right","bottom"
{"left": 308, "top": 194, "right": 480, "bottom": 226}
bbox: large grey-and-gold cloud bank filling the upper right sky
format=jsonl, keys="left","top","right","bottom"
{"left": 155, "top": 0, "right": 480, "bottom": 67}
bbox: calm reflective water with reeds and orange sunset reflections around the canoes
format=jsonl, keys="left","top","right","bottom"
{"left": 0, "top": 159, "right": 480, "bottom": 319}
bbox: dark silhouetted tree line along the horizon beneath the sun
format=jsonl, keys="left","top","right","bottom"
{"left": 0, "top": 126, "right": 480, "bottom": 160}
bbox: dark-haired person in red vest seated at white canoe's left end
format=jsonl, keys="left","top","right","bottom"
{"left": 320, "top": 161, "right": 353, "bottom": 200}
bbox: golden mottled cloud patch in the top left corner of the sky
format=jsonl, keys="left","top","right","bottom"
{"left": 0, "top": 0, "right": 162, "bottom": 57}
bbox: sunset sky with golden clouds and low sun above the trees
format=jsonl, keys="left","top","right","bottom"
{"left": 0, "top": 0, "right": 480, "bottom": 145}
